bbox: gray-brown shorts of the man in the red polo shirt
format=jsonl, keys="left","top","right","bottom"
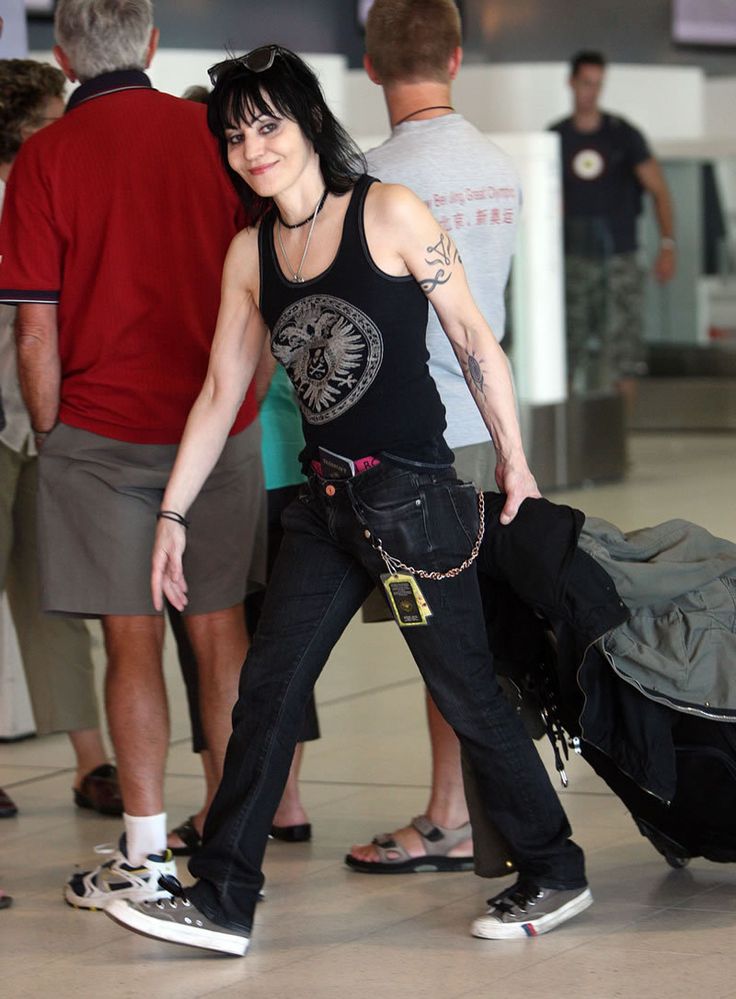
{"left": 38, "top": 421, "right": 266, "bottom": 617}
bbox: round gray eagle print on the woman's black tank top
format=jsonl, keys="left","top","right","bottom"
{"left": 271, "top": 295, "right": 383, "bottom": 426}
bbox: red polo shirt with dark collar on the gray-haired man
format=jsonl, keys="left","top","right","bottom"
{"left": 0, "top": 71, "right": 256, "bottom": 444}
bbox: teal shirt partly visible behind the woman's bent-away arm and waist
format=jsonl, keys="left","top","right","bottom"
{"left": 260, "top": 364, "right": 304, "bottom": 489}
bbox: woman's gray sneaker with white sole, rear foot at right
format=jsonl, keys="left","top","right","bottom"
{"left": 471, "top": 880, "right": 593, "bottom": 940}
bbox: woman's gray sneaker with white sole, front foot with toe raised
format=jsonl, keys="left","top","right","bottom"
{"left": 104, "top": 877, "right": 250, "bottom": 957}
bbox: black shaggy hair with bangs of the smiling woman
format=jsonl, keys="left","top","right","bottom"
{"left": 207, "top": 46, "right": 366, "bottom": 225}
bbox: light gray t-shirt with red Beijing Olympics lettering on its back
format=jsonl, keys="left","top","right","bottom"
{"left": 367, "top": 113, "right": 520, "bottom": 447}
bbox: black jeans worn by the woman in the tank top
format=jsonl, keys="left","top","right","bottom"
{"left": 189, "top": 462, "right": 586, "bottom": 930}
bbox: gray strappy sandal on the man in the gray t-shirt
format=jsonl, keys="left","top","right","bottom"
{"left": 345, "top": 815, "right": 473, "bottom": 874}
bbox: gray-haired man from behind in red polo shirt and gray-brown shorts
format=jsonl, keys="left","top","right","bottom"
{"left": 0, "top": 0, "right": 264, "bottom": 908}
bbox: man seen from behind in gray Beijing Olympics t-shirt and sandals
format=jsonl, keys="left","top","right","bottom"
{"left": 346, "top": 0, "right": 520, "bottom": 888}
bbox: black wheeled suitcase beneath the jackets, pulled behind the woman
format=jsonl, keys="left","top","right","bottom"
{"left": 482, "top": 580, "right": 736, "bottom": 867}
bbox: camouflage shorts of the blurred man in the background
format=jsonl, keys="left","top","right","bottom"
{"left": 565, "top": 252, "right": 647, "bottom": 391}
